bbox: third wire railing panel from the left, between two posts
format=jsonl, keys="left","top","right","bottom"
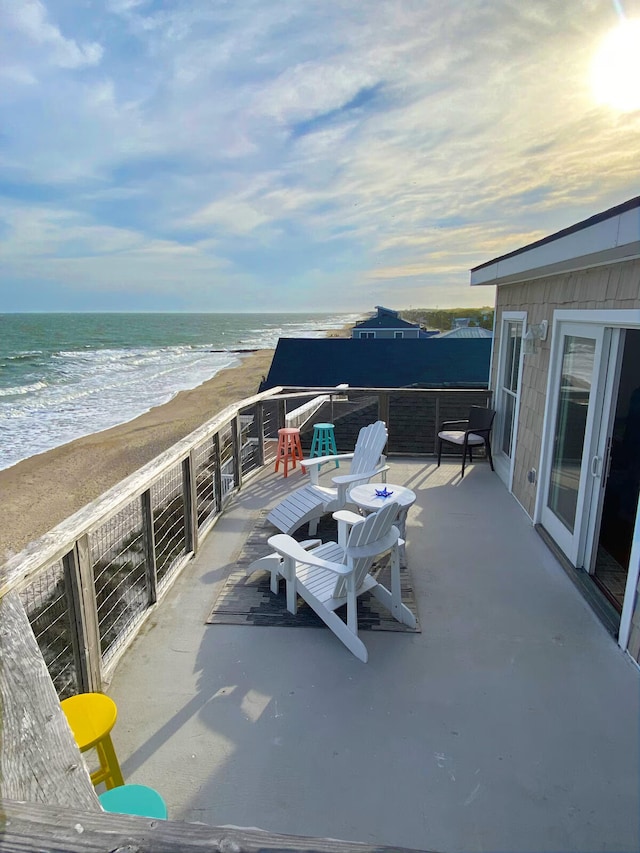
{"left": 151, "top": 465, "right": 186, "bottom": 588}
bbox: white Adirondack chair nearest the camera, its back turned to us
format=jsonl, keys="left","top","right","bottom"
{"left": 269, "top": 502, "right": 416, "bottom": 663}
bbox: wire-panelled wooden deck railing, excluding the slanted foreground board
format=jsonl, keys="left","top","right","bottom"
{"left": 0, "top": 389, "right": 488, "bottom": 698}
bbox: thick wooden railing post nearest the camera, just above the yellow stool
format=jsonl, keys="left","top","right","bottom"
{"left": 62, "top": 535, "right": 102, "bottom": 692}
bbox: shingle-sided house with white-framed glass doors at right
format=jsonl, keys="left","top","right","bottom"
{"left": 470, "top": 197, "right": 640, "bottom": 660}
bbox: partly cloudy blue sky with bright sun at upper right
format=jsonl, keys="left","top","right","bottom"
{"left": 0, "top": 0, "right": 640, "bottom": 312}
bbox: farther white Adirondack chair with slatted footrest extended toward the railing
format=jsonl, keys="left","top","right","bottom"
{"left": 267, "top": 421, "right": 388, "bottom": 536}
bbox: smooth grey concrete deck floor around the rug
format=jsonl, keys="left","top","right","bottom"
{"left": 108, "top": 458, "right": 640, "bottom": 851}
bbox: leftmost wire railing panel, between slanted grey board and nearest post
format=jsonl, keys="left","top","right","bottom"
{"left": 20, "top": 560, "right": 80, "bottom": 699}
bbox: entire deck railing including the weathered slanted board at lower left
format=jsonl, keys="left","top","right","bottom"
{"left": 0, "top": 386, "right": 489, "bottom": 850}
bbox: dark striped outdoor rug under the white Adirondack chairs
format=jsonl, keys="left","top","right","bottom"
{"left": 207, "top": 512, "right": 421, "bottom": 634}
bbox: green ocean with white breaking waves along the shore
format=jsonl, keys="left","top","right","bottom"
{"left": 0, "top": 313, "right": 359, "bottom": 469}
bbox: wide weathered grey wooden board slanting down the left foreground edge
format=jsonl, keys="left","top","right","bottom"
{"left": 0, "top": 590, "right": 102, "bottom": 808}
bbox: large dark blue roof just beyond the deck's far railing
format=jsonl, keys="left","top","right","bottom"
{"left": 260, "top": 338, "right": 493, "bottom": 390}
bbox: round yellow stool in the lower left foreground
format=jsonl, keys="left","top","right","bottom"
{"left": 60, "top": 693, "right": 124, "bottom": 788}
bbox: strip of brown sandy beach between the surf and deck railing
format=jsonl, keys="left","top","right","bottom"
{"left": 0, "top": 350, "right": 273, "bottom": 562}
